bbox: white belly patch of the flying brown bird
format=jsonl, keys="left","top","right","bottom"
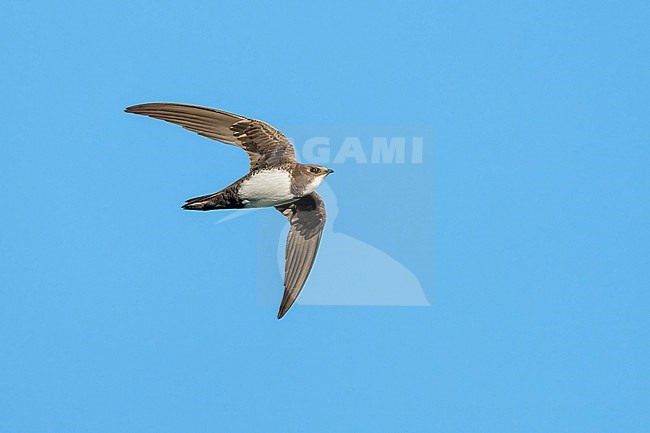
{"left": 239, "top": 168, "right": 295, "bottom": 207}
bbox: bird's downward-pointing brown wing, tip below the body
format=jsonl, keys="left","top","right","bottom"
{"left": 275, "top": 192, "right": 327, "bottom": 319}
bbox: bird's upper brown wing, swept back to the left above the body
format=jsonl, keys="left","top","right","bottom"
{"left": 124, "top": 102, "right": 296, "bottom": 170}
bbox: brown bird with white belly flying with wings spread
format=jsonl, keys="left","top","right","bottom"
{"left": 124, "top": 102, "right": 334, "bottom": 319}
